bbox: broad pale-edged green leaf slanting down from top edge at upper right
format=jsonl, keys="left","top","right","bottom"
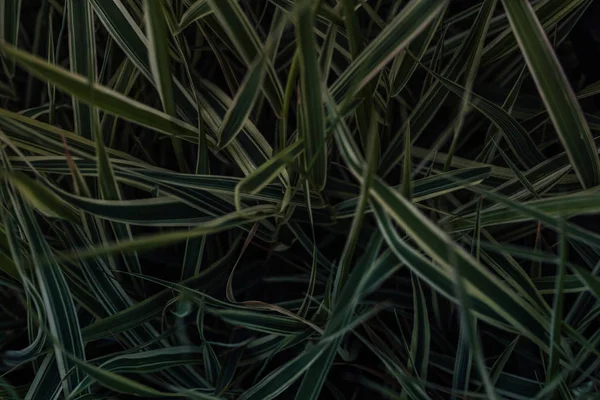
{"left": 502, "top": 0, "right": 600, "bottom": 188}
